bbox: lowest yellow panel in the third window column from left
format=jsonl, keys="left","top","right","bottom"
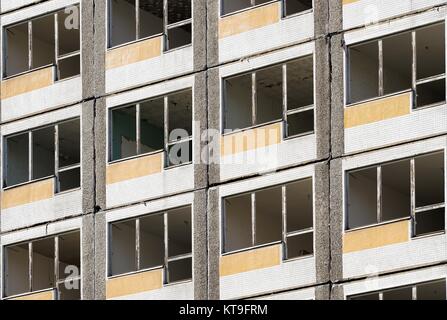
{"left": 220, "top": 245, "right": 281, "bottom": 277}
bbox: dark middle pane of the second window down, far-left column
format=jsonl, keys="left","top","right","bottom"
{"left": 32, "top": 126, "right": 55, "bottom": 179}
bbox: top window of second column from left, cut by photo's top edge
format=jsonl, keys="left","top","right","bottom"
{"left": 109, "top": 0, "right": 192, "bottom": 50}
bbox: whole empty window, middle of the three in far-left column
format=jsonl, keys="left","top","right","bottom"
{"left": 3, "top": 118, "right": 81, "bottom": 192}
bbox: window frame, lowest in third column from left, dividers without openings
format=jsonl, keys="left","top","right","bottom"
{"left": 221, "top": 177, "right": 315, "bottom": 261}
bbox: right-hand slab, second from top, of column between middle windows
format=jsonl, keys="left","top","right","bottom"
{"left": 208, "top": 68, "right": 221, "bottom": 185}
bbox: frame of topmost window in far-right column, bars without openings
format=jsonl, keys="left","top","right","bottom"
{"left": 344, "top": 21, "right": 447, "bottom": 111}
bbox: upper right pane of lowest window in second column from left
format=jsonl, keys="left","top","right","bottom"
{"left": 168, "top": 207, "right": 192, "bottom": 257}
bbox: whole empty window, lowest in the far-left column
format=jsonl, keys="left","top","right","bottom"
{"left": 4, "top": 232, "right": 81, "bottom": 300}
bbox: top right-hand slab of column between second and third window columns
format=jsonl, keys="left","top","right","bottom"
{"left": 207, "top": 0, "right": 220, "bottom": 68}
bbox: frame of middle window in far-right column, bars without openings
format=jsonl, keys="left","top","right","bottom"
{"left": 344, "top": 150, "right": 447, "bottom": 238}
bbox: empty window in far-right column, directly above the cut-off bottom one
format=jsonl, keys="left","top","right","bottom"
{"left": 346, "top": 152, "right": 445, "bottom": 236}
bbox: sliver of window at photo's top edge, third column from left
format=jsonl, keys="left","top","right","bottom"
{"left": 221, "top": 0, "right": 312, "bottom": 16}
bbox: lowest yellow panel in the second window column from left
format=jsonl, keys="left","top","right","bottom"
{"left": 106, "top": 269, "right": 163, "bottom": 299}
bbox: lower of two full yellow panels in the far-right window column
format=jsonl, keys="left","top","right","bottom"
{"left": 343, "top": 220, "right": 410, "bottom": 253}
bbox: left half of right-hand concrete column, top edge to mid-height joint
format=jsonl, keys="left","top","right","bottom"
{"left": 314, "top": 0, "right": 331, "bottom": 159}
